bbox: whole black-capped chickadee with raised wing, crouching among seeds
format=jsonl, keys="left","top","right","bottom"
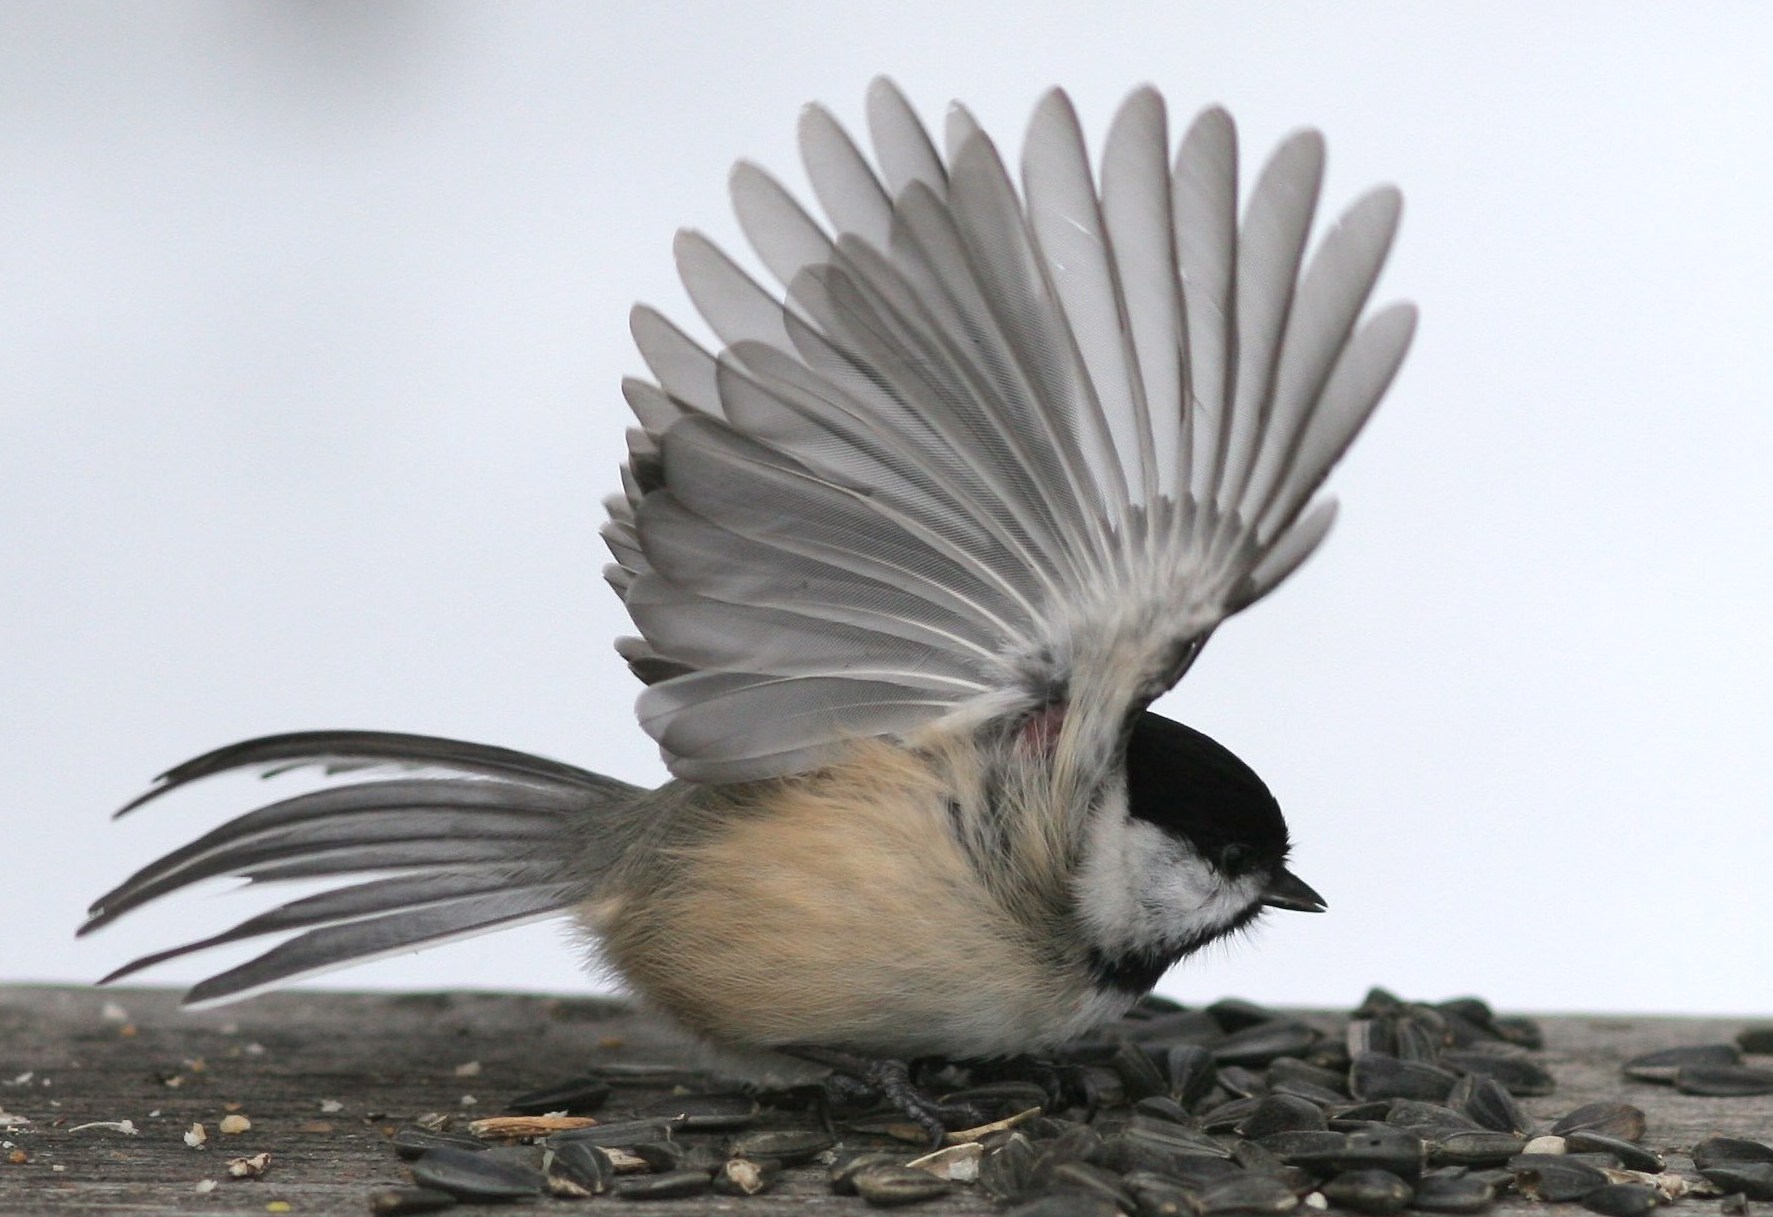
{"left": 80, "top": 80, "right": 1417, "bottom": 1137}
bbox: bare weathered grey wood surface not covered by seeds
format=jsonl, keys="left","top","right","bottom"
{"left": 0, "top": 986, "right": 1773, "bottom": 1217}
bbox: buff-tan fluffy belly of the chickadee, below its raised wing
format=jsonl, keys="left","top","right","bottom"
{"left": 596, "top": 759, "right": 1128, "bottom": 1057}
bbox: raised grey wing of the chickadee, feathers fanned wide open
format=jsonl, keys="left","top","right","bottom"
{"left": 605, "top": 82, "right": 1415, "bottom": 782}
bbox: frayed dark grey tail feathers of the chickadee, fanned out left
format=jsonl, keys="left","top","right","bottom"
{"left": 80, "top": 731, "right": 645, "bottom": 1004}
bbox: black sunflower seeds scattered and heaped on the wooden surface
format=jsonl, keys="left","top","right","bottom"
{"left": 371, "top": 988, "right": 1773, "bottom": 1217}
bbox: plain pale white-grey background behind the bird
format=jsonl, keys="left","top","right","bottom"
{"left": 0, "top": 0, "right": 1773, "bottom": 1015}
